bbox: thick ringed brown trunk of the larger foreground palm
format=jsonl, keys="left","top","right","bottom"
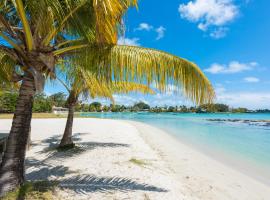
{"left": 0, "top": 73, "right": 35, "bottom": 197}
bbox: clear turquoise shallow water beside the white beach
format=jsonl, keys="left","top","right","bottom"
{"left": 82, "top": 113, "right": 270, "bottom": 180}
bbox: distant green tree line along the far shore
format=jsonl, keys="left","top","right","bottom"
{"left": 0, "top": 91, "right": 270, "bottom": 113}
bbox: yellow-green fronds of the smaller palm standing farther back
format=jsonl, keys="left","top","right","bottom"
{"left": 58, "top": 62, "right": 155, "bottom": 101}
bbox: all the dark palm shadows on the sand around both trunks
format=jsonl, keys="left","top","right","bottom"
{"left": 25, "top": 134, "right": 167, "bottom": 193}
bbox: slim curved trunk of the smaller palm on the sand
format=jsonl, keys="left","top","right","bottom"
{"left": 59, "top": 92, "right": 77, "bottom": 148}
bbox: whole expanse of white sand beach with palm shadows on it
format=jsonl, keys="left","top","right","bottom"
{"left": 0, "top": 119, "right": 270, "bottom": 200}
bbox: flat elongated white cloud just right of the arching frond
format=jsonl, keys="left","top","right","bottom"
{"left": 204, "top": 61, "right": 258, "bottom": 74}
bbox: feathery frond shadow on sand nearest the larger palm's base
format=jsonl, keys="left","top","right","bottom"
{"left": 26, "top": 159, "right": 168, "bottom": 193}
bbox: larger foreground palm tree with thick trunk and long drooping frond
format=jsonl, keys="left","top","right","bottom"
{"left": 0, "top": 0, "right": 214, "bottom": 197}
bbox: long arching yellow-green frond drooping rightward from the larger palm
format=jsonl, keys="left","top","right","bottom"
{"left": 72, "top": 45, "right": 215, "bottom": 104}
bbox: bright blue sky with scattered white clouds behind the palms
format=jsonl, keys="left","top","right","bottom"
{"left": 46, "top": 0, "right": 270, "bottom": 108}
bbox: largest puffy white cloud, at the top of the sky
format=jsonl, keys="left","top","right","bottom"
{"left": 178, "top": 0, "right": 239, "bottom": 39}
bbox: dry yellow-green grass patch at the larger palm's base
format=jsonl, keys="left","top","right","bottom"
{"left": 3, "top": 181, "right": 57, "bottom": 200}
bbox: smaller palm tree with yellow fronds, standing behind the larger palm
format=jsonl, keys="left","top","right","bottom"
{"left": 57, "top": 65, "right": 155, "bottom": 148}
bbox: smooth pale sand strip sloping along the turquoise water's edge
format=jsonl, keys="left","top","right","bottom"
{"left": 129, "top": 121, "right": 270, "bottom": 199}
